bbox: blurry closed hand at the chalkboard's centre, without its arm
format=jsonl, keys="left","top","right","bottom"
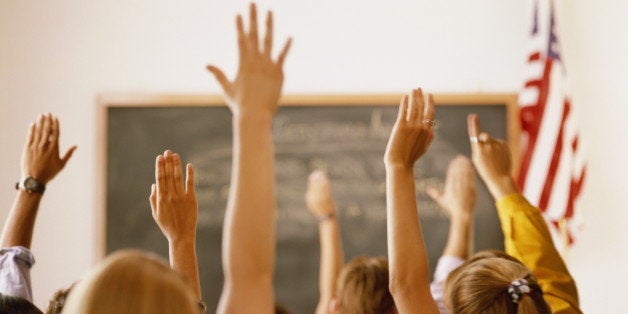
{"left": 305, "top": 170, "right": 336, "bottom": 219}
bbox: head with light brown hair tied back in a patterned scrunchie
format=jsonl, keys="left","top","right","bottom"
{"left": 445, "top": 254, "right": 550, "bottom": 314}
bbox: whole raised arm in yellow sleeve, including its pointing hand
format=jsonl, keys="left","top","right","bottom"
{"left": 468, "top": 115, "right": 581, "bottom": 313}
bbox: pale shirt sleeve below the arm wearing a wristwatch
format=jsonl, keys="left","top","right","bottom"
{"left": 0, "top": 246, "right": 35, "bottom": 302}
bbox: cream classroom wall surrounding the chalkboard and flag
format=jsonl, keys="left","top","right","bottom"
{"left": 0, "top": 0, "right": 628, "bottom": 313}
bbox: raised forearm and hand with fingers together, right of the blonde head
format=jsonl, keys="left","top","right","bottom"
{"left": 150, "top": 150, "right": 202, "bottom": 301}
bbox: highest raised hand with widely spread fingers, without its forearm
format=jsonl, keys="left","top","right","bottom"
{"left": 207, "top": 4, "right": 292, "bottom": 116}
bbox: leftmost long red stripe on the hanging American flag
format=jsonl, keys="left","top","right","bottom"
{"left": 517, "top": 59, "right": 553, "bottom": 189}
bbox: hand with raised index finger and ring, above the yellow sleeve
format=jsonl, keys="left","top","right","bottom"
{"left": 467, "top": 114, "right": 518, "bottom": 200}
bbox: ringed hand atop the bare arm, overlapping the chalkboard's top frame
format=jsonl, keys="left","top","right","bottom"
{"left": 384, "top": 88, "right": 434, "bottom": 168}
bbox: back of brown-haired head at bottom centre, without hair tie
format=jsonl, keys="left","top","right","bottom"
{"left": 336, "top": 256, "right": 395, "bottom": 314}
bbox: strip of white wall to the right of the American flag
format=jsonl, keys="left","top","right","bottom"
{"left": 558, "top": 0, "right": 628, "bottom": 313}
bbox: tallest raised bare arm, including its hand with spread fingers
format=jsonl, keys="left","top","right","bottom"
{"left": 208, "top": 4, "right": 290, "bottom": 313}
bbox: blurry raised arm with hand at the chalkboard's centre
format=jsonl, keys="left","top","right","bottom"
{"left": 305, "top": 171, "right": 344, "bottom": 314}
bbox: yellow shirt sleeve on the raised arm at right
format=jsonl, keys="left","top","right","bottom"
{"left": 497, "top": 194, "right": 582, "bottom": 313}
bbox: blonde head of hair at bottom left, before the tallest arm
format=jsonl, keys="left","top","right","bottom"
{"left": 63, "top": 250, "right": 199, "bottom": 314}
